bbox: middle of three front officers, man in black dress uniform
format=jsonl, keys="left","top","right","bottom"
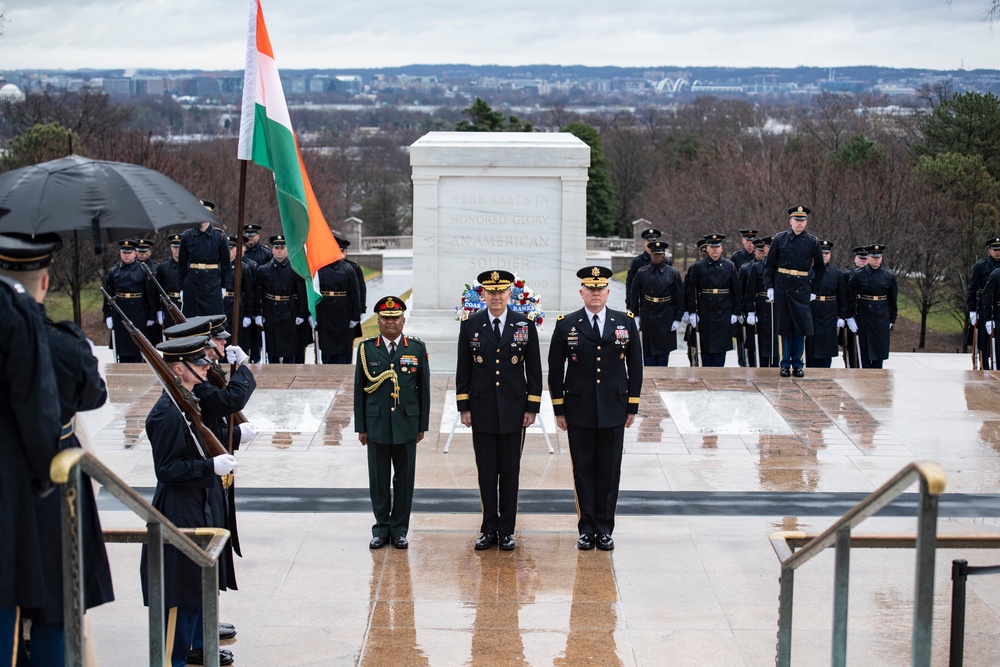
{"left": 455, "top": 270, "right": 542, "bottom": 551}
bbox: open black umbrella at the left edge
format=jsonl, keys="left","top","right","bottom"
{"left": 0, "top": 155, "right": 217, "bottom": 252}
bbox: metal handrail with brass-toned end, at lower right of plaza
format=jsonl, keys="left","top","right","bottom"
{"left": 770, "top": 462, "right": 947, "bottom": 667}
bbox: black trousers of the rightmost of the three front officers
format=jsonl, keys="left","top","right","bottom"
{"left": 567, "top": 424, "right": 625, "bottom": 535}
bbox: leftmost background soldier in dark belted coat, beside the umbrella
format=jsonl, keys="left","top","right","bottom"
{"left": 104, "top": 240, "right": 159, "bottom": 364}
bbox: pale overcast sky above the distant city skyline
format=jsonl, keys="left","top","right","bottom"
{"left": 0, "top": 0, "right": 1000, "bottom": 71}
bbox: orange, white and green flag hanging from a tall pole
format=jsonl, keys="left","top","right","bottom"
{"left": 237, "top": 0, "right": 344, "bottom": 315}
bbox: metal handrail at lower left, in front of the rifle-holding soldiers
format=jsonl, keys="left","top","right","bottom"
{"left": 49, "top": 447, "right": 229, "bottom": 667}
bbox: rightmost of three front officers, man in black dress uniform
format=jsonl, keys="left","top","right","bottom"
{"left": 549, "top": 266, "right": 642, "bottom": 551}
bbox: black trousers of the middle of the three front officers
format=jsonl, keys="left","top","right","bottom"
{"left": 472, "top": 428, "right": 524, "bottom": 535}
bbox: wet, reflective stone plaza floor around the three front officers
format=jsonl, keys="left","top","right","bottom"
{"left": 83, "top": 353, "right": 1000, "bottom": 667}
